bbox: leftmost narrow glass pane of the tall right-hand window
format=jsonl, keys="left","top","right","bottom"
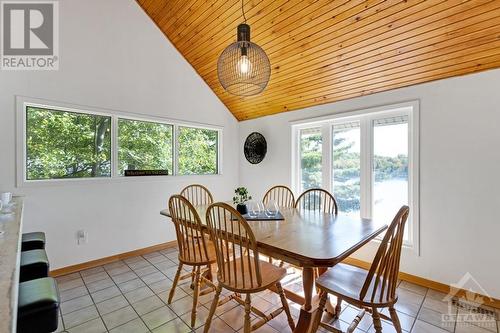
{"left": 300, "top": 127, "right": 323, "bottom": 191}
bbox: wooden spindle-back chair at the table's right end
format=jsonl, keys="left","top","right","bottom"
{"left": 312, "top": 206, "right": 410, "bottom": 333}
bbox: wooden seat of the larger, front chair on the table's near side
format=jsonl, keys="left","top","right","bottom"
{"left": 219, "top": 258, "right": 286, "bottom": 293}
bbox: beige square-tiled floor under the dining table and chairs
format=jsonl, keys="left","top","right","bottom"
{"left": 52, "top": 245, "right": 500, "bottom": 333}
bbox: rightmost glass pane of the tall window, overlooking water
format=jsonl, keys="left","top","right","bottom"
{"left": 373, "top": 117, "right": 408, "bottom": 239}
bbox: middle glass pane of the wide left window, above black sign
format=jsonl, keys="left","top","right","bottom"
{"left": 118, "top": 119, "right": 173, "bottom": 175}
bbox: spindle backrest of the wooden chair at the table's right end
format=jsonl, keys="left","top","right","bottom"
{"left": 360, "top": 206, "right": 410, "bottom": 303}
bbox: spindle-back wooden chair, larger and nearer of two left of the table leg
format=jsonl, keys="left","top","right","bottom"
{"left": 204, "top": 203, "right": 295, "bottom": 333}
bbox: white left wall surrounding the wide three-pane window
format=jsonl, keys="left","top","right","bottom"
{"left": 0, "top": 0, "right": 238, "bottom": 269}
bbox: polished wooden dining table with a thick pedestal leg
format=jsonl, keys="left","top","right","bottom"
{"left": 160, "top": 205, "right": 387, "bottom": 333}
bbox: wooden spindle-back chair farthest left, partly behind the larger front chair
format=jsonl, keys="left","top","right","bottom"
{"left": 168, "top": 195, "right": 216, "bottom": 327}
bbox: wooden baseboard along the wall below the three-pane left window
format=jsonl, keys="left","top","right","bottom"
{"left": 50, "top": 241, "right": 177, "bottom": 277}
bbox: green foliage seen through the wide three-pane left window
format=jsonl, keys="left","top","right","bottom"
{"left": 26, "top": 106, "right": 218, "bottom": 180}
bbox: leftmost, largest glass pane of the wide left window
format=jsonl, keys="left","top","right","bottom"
{"left": 26, "top": 106, "right": 111, "bottom": 180}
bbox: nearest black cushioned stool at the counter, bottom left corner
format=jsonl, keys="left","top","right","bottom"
{"left": 17, "top": 277, "right": 60, "bottom": 333}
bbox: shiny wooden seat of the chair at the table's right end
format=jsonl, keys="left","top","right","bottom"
{"left": 316, "top": 264, "right": 397, "bottom": 307}
